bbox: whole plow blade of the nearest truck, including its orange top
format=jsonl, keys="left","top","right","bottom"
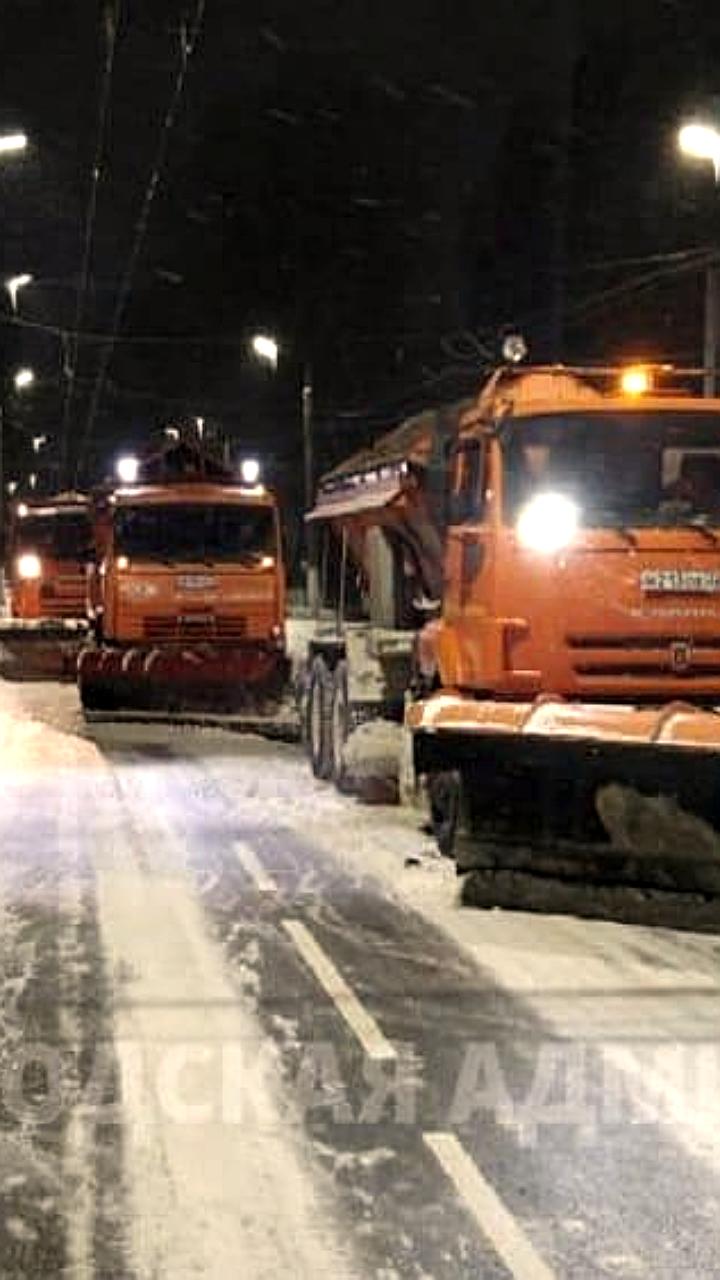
{"left": 407, "top": 694, "right": 720, "bottom": 914}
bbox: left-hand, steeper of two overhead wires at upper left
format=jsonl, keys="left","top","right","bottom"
{"left": 60, "top": 0, "right": 122, "bottom": 475}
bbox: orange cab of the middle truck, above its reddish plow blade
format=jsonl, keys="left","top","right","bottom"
{"left": 94, "top": 483, "right": 284, "bottom": 648}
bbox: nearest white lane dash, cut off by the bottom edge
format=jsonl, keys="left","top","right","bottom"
{"left": 423, "top": 1133, "right": 556, "bottom": 1280}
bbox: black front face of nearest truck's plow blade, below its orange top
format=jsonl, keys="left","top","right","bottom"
{"left": 414, "top": 712, "right": 720, "bottom": 914}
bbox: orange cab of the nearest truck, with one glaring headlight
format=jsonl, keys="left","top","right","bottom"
{"left": 433, "top": 370, "right": 720, "bottom": 701}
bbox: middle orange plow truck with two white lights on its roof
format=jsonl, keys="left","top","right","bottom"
{"left": 78, "top": 445, "right": 287, "bottom": 717}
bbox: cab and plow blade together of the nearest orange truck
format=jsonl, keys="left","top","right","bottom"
{"left": 407, "top": 367, "right": 720, "bottom": 896}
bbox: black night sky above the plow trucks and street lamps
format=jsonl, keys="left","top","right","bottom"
{"left": 0, "top": 0, "right": 720, "bottom": 504}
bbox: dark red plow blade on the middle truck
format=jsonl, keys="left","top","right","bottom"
{"left": 78, "top": 645, "right": 287, "bottom": 724}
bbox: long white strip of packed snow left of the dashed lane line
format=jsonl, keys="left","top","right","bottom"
{"left": 89, "top": 755, "right": 355, "bottom": 1280}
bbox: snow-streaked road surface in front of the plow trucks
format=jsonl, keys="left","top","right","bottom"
{"left": 0, "top": 684, "right": 720, "bottom": 1280}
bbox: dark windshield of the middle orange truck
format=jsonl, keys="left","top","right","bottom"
{"left": 115, "top": 503, "right": 277, "bottom": 563}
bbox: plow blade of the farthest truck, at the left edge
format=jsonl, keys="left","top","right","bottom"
{"left": 0, "top": 618, "right": 88, "bottom": 681}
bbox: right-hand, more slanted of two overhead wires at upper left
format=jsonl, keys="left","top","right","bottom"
{"left": 76, "top": 0, "right": 206, "bottom": 485}
